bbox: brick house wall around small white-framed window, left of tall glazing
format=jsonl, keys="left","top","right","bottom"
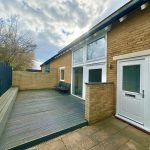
{"left": 50, "top": 51, "right": 72, "bottom": 83}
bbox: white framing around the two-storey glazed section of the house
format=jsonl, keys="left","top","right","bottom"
{"left": 71, "top": 31, "right": 107, "bottom": 99}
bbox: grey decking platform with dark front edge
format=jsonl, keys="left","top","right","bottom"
{"left": 0, "top": 90, "right": 87, "bottom": 150}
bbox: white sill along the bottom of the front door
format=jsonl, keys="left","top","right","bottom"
{"left": 115, "top": 114, "right": 150, "bottom": 134}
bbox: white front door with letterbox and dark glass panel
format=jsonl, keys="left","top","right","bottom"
{"left": 117, "top": 57, "right": 148, "bottom": 125}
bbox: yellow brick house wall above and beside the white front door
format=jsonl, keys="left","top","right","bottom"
{"left": 107, "top": 7, "right": 150, "bottom": 83}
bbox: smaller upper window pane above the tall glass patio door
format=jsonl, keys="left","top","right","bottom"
{"left": 73, "top": 48, "right": 83, "bottom": 64}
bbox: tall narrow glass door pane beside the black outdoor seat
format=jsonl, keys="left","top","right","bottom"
{"left": 73, "top": 67, "right": 83, "bottom": 97}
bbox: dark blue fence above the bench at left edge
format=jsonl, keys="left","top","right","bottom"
{"left": 0, "top": 63, "right": 12, "bottom": 96}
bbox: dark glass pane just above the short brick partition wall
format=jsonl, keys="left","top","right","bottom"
{"left": 89, "top": 69, "right": 102, "bottom": 82}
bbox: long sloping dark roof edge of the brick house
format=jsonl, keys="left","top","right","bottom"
{"left": 41, "top": 0, "right": 149, "bottom": 66}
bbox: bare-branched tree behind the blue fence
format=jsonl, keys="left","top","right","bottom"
{"left": 0, "top": 17, "right": 36, "bottom": 70}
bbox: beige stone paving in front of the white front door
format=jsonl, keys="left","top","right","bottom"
{"left": 28, "top": 117, "right": 150, "bottom": 150}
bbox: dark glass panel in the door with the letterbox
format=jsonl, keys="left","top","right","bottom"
{"left": 123, "top": 65, "right": 140, "bottom": 93}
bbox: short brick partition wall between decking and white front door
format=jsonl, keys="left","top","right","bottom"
{"left": 85, "top": 83, "right": 115, "bottom": 124}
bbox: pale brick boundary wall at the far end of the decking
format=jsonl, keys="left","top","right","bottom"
{"left": 12, "top": 69, "right": 57, "bottom": 90}
